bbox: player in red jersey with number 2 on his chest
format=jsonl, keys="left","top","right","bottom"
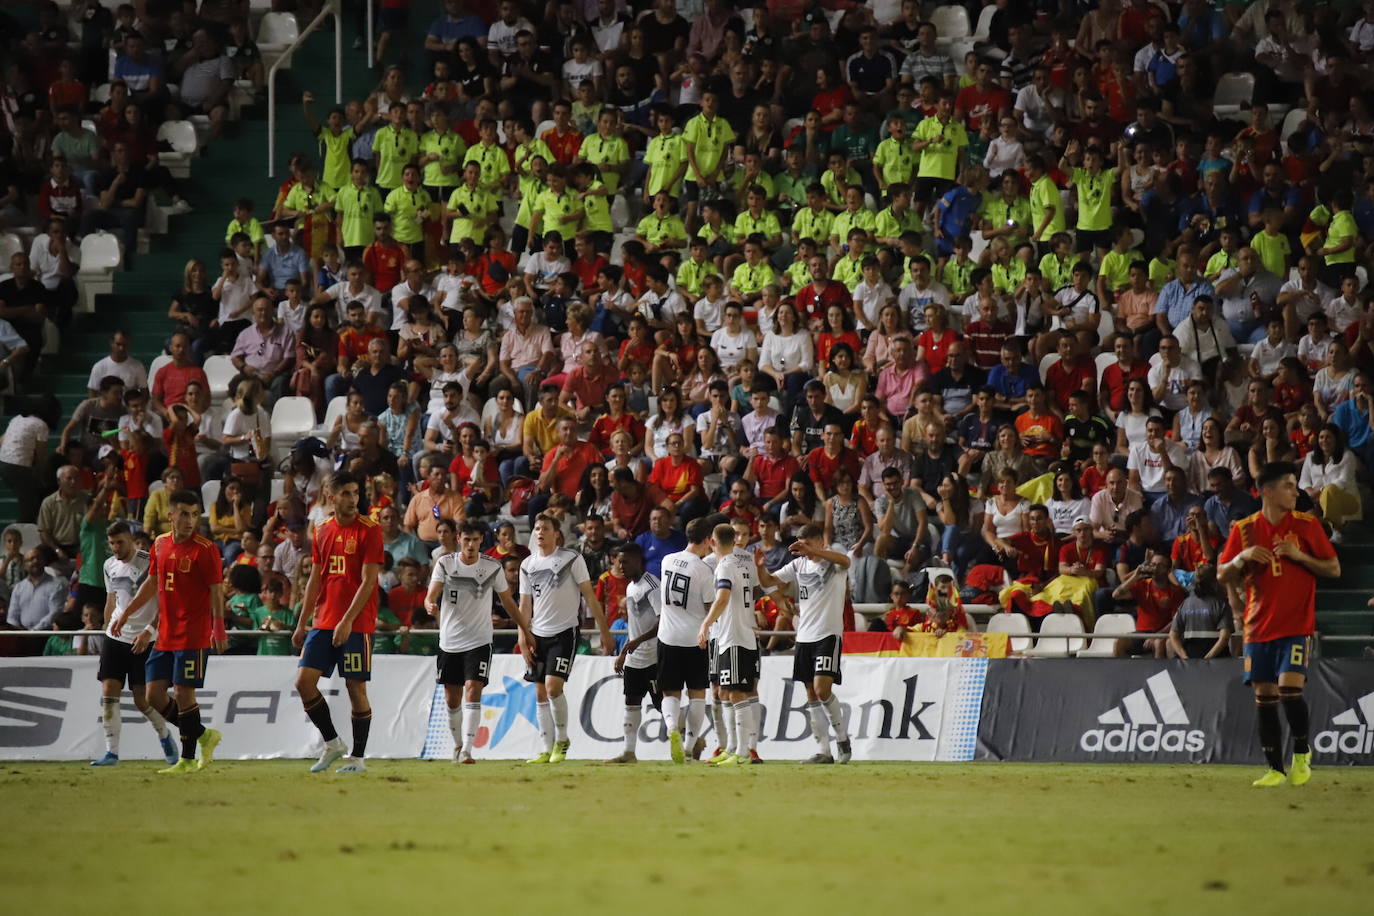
{"left": 110, "top": 490, "right": 229, "bottom": 773}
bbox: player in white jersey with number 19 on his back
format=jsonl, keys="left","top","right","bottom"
{"left": 658, "top": 518, "right": 724, "bottom": 764}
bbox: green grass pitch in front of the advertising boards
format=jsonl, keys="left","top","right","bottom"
{"left": 0, "top": 761, "right": 1374, "bottom": 916}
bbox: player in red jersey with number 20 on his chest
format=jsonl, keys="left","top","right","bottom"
{"left": 291, "top": 471, "right": 382, "bottom": 773}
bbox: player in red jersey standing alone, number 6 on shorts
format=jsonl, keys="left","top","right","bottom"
{"left": 1219, "top": 461, "right": 1341, "bottom": 786}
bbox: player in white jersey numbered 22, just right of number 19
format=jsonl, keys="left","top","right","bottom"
{"left": 697, "top": 525, "right": 761, "bottom": 766}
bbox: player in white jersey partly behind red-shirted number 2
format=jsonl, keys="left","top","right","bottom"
{"left": 91, "top": 522, "right": 179, "bottom": 766}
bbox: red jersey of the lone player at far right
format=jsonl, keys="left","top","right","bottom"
{"left": 1217, "top": 512, "right": 1336, "bottom": 643}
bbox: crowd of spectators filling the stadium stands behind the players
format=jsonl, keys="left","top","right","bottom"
{"left": 0, "top": 0, "right": 1374, "bottom": 655}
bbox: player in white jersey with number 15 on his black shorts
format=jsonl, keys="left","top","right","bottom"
{"left": 519, "top": 512, "right": 616, "bottom": 764}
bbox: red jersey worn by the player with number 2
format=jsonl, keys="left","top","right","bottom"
{"left": 148, "top": 534, "right": 224, "bottom": 652}
